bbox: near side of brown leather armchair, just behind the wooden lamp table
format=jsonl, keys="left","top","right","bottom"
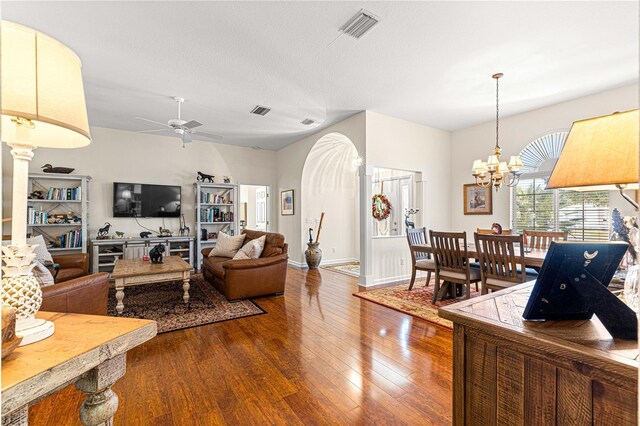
{"left": 40, "top": 272, "right": 109, "bottom": 315}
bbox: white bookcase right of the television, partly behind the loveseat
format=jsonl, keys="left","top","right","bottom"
{"left": 194, "top": 182, "right": 239, "bottom": 271}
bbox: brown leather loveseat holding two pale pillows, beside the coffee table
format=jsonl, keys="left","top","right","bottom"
{"left": 202, "top": 229, "right": 289, "bottom": 300}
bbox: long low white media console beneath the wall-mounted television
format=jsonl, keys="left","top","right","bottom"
{"left": 91, "top": 237, "right": 195, "bottom": 274}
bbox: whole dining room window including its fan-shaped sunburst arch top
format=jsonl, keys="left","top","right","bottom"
{"left": 511, "top": 131, "right": 610, "bottom": 240}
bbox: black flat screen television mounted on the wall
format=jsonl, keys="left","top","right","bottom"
{"left": 113, "top": 182, "right": 181, "bottom": 217}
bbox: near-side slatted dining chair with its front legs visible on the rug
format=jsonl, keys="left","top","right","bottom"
{"left": 429, "top": 231, "right": 482, "bottom": 304}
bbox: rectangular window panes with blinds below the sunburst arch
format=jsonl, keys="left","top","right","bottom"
{"left": 511, "top": 174, "right": 609, "bottom": 241}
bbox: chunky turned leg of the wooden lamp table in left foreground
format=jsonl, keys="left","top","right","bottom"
{"left": 76, "top": 354, "right": 126, "bottom": 426}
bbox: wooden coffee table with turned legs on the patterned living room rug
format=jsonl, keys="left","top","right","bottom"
{"left": 111, "top": 256, "right": 191, "bottom": 314}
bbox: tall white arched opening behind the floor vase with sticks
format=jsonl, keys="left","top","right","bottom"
{"left": 301, "top": 132, "right": 360, "bottom": 275}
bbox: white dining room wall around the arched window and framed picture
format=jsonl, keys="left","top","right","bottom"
{"left": 449, "top": 84, "right": 638, "bottom": 238}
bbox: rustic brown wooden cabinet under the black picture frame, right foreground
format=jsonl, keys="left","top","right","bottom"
{"left": 439, "top": 283, "right": 638, "bottom": 426}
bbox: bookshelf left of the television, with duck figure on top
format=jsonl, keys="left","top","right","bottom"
{"left": 27, "top": 173, "right": 91, "bottom": 254}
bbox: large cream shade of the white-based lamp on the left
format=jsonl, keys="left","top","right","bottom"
{"left": 1, "top": 21, "right": 91, "bottom": 148}
